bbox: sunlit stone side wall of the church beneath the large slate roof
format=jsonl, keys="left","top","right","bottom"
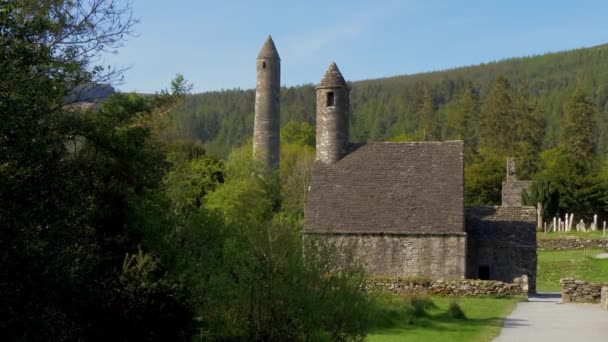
{"left": 308, "top": 234, "right": 466, "bottom": 278}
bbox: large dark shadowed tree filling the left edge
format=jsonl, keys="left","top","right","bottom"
{"left": 0, "top": 0, "right": 191, "bottom": 340}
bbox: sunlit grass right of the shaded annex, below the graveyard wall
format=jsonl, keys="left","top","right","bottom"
{"left": 536, "top": 248, "right": 608, "bottom": 292}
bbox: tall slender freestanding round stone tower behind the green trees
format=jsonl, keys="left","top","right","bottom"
{"left": 253, "top": 36, "right": 281, "bottom": 171}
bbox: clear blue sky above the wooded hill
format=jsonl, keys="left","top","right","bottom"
{"left": 105, "top": 0, "right": 608, "bottom": 92}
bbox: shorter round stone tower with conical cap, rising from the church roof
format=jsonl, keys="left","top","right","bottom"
{"left": 315, "top": 63, "right": 350, "bottom": 164}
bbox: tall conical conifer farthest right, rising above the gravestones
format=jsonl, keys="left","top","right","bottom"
{"left": 560, "top": 80, "right": 596, "bottom": 161}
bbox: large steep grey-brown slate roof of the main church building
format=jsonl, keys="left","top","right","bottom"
{"left": 304, "top": 141, "right": 464, "bottom": 234}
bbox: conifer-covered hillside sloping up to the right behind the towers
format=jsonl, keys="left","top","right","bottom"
{"left": 169, "top": 45, "right": 608, "bottom": 155}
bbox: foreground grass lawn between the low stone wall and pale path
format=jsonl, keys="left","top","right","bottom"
{"left": 368, "top": 296, "right": 522, "bottom": 342}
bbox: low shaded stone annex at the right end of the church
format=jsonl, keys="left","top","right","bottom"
{"left": 465, "top": 207, "right": 537, "bottom": 293}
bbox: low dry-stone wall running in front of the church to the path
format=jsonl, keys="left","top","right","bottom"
{"left": 368, "top": 276, "right": 528, "bottom": 297}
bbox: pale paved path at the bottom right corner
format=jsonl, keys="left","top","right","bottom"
{"left": 494, "top": 294, "right": 608, "bottom": 342}
